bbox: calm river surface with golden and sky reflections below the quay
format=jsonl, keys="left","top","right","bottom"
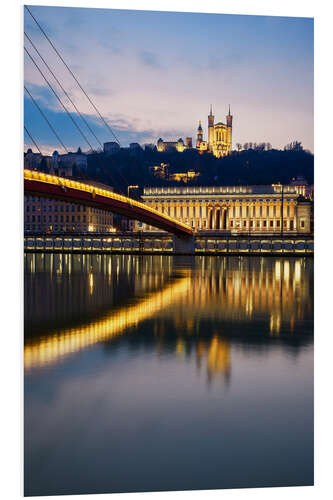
{"left": 25, "top": 254, "right": 313, "bottom": 495}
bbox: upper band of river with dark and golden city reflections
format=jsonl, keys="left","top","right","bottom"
{"left": 24, "top": 254, "right": 313, "bottom": 377}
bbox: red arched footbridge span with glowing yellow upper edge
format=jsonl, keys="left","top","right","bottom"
{"left": 24, "top": 170, "right": 193, "bottom": 236}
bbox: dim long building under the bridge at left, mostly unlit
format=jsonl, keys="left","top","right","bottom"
{"left": 24, "top": 195, "right": 114, "bottom": 233}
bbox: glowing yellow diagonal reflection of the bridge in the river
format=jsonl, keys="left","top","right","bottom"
{"left": 24, "top": 276, "right": 191, "bottom": 370}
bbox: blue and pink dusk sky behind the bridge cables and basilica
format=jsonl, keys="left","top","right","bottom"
{"left": 24, "top": 6, "right": 313, "bottom": 154}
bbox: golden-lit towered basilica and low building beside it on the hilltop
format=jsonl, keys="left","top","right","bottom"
{"left": 157, "top": 105, "right": 232, "bottom": 158}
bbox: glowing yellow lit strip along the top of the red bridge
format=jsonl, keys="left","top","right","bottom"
{"left": 24, "top": 169, "right": 193, "bottom": 231}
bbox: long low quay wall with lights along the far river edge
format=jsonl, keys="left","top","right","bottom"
{"left": 24, "top": 233, "right": 314, "bottom": 256}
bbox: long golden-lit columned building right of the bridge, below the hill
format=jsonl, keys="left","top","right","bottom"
{"left": 142, "top": 184, "right": 312, "bottom": 234}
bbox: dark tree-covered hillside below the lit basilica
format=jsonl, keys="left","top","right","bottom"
{"left": 87, "top": 145, "right": 314, "bottom": 193}
